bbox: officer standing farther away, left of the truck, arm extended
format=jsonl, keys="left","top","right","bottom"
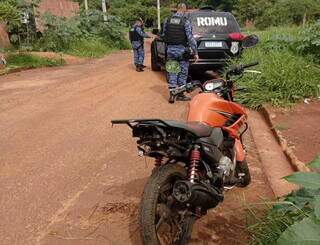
{"left": 129, "top": 19, "right": 150, "bottom": 72}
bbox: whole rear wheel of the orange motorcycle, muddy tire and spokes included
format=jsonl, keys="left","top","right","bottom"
{"left": 139, "top": 164, "right": 195, "bottom": 245}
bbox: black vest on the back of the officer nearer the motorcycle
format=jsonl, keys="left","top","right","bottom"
{"left": 165, "top": 16, "right": 188, "bottom": 46}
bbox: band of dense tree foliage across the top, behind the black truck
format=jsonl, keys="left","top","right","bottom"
{"left": 73, "top": 0, "right": 320, "bottom": 29}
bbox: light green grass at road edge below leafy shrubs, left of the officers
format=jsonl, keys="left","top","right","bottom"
{"left": 65, "top": 39, "right": 117, "bottom": 58}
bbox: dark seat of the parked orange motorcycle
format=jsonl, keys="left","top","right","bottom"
{"left": 165, "top": 121, "right": 213, "bottom": 138}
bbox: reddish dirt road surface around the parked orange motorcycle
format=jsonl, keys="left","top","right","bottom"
{"left": 0, "top": 48, "right": 272, "bottom": 245}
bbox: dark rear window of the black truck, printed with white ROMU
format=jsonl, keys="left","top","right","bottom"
{"left": 189, "top": 11, "right": 240, "bottom": 35}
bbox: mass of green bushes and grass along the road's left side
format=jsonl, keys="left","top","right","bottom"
{"left": 0, "top": 0, "right": 129, "bottom": 67}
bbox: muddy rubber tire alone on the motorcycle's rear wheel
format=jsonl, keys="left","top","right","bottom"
{"left": 139, "top": 164, "right": 195, "bottom": 245}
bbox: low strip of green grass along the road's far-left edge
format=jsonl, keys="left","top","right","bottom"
{"left": 6, "top": 53, "right": 65, "bottom": 70}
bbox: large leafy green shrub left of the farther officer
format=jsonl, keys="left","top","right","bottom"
{"left": 36, "top": 10, "right": 129, "bottom": 56}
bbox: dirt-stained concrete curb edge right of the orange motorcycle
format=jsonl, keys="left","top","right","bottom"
{"left": 261, "top": 106, "right": 311, "bottom": 172}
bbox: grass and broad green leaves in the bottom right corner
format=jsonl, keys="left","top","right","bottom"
{"left": 248, "top": 155, "right": 320, "bottom": 245}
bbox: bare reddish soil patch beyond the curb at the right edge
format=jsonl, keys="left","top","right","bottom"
{"left": 273, "top": 101, "right": 320, "bottom": 163}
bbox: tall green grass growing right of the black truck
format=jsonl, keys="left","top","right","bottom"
{"left": 232, "top": 27, "right": 320, "bottom": 108}
